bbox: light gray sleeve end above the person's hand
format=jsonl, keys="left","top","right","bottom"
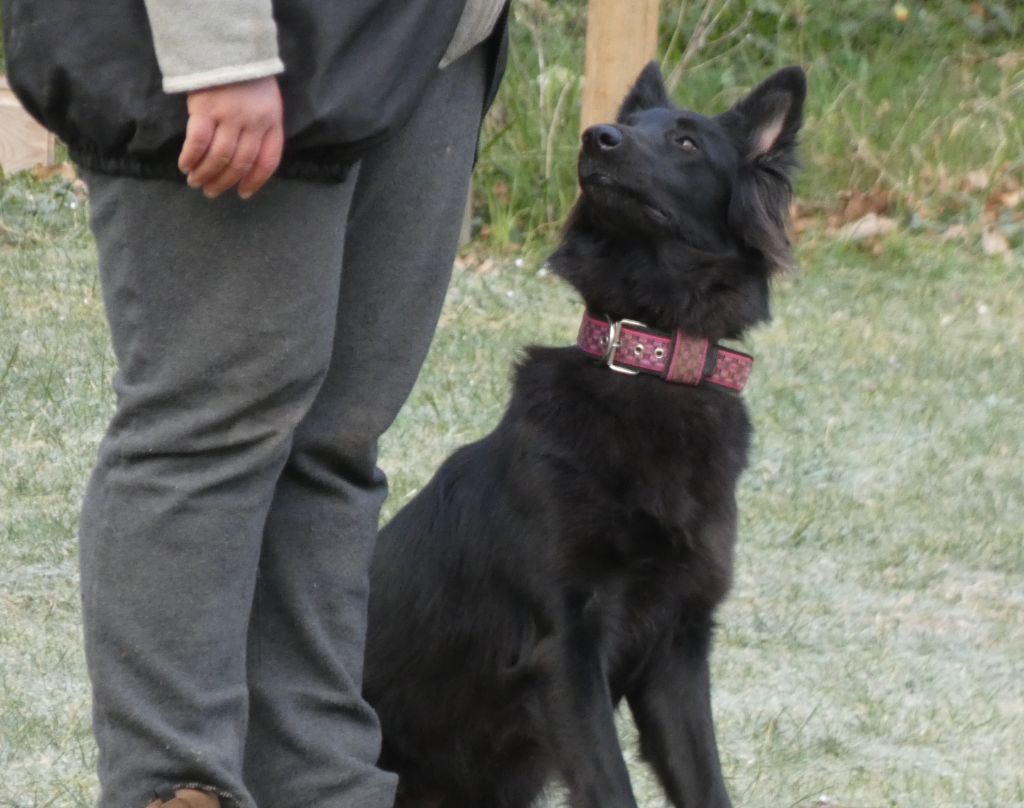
{"left": 145, "top": 0, "right": 285, "bottom": 93}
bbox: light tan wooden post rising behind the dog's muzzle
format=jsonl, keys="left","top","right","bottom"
{"left": 582, "top": 0, "right": 659, "bottom": 129}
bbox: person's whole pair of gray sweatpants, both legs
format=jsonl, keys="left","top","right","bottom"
{"left": 81, "top": 48, "right": 486, "bottom": 808}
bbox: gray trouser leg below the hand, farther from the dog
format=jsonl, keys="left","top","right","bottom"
{"left": 81, "top": 175, "right": 354, "bottom": 808}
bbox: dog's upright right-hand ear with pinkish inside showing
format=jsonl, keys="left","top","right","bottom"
{"left": 722, "top": 67, "right": 807, "bottom": 161}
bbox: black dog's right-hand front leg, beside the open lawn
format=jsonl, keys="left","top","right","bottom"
{"left": 626, "top": 614, "right": 731, "bottom": 808}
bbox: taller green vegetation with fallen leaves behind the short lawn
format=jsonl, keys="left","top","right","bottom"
{"left": 474, "top": 0, "right": 1024, "bottom": 248}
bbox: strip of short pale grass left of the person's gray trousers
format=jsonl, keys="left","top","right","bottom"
{"left": 0, "top": 179, "right": 102, "bottom": 808}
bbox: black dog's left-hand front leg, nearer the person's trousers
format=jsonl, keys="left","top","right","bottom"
{"left": 543, "top": 593, "right": 637, "bottom": 808}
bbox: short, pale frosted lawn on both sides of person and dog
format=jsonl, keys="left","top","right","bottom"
{"left": 0, "top": 172, "right": 1024, "bottom": 808}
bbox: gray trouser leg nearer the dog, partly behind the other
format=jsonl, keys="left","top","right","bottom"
{"left": 246, "top": 42, "right": 485, "bottom": 808}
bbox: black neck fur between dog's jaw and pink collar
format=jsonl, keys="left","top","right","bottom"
{"left": 549, "top": 207, "right": 770, "bottom": 341}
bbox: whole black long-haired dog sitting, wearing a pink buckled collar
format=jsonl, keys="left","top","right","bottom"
{"left": 365, "top": 63, "right": 806, "bottom": 808}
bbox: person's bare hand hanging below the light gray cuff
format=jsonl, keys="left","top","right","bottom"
{"left": 178, "top": 76, "right": 285, "bottom": 199}
